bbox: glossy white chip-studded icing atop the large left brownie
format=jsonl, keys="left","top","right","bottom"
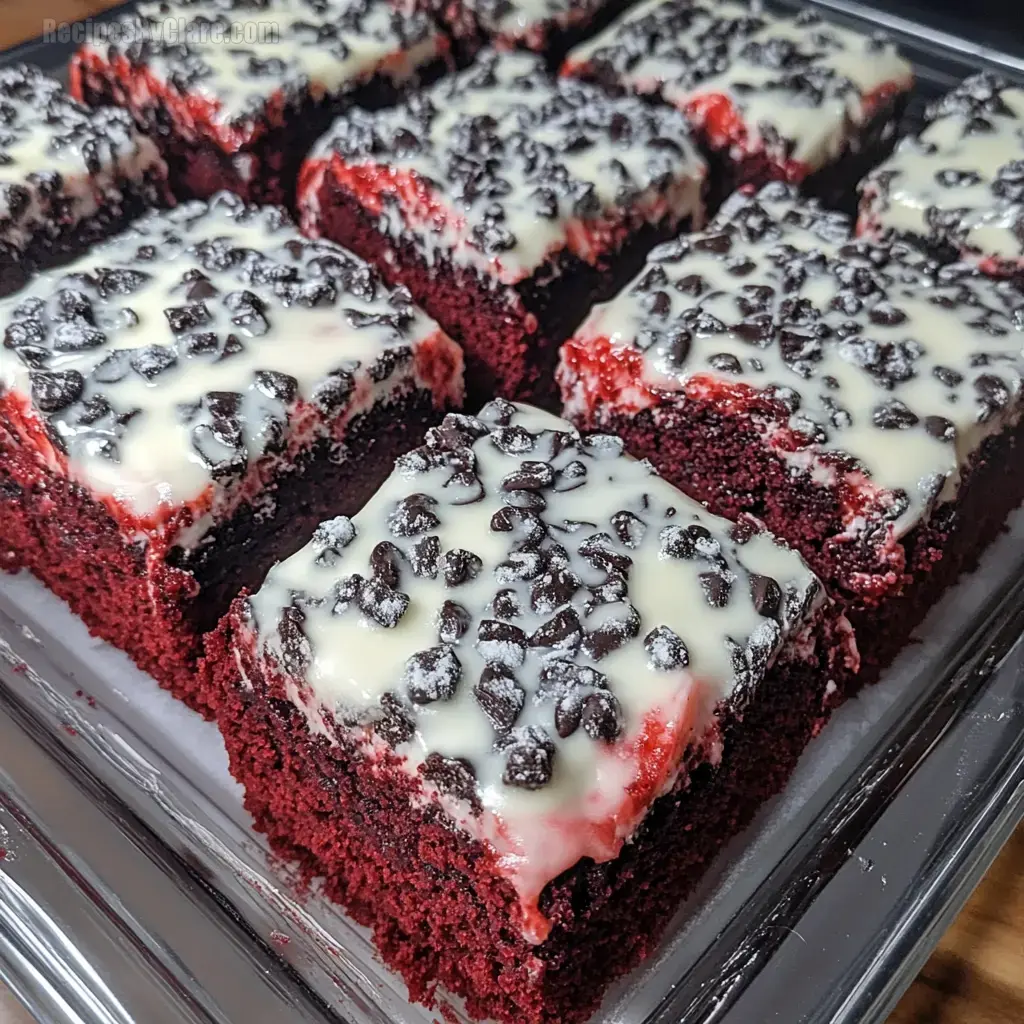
{"left": 0, "top": 195, "right": 461, "bottom": 536}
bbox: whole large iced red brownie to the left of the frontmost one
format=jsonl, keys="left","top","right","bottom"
{"left": 0, "top": 194, "right": 462, "bottom": 710}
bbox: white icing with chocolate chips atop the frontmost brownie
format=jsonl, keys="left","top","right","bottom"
{"left": 245, "top": 401, "right": 824, "bottom": 940}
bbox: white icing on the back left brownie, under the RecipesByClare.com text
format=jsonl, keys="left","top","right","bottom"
{"left": 84, "top": 0, "right": 442, "bottom": 132}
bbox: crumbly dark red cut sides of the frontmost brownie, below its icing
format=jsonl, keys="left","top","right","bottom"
{"left": 205, "top": 569, "right": 849, "bottom": 1024}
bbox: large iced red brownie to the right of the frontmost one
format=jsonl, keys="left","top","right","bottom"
{"left": 558, "top": 184, "right": 1024, "bottom": 682}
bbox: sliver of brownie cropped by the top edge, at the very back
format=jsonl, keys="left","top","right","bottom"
{"left": 420, "top": 0, "right": 629, "bottom": 68}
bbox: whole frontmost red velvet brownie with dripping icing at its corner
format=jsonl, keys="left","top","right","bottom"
{"left": 206, "top": 399, "right": 856, "bottom": 1024}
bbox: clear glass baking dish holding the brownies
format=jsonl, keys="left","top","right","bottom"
{"left": 0, "top": 0, "right": 1024, "bottom": 1024}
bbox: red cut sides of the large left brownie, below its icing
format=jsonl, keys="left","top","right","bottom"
{"left": 0, "top": 392, "right": 442, "bottom": 718}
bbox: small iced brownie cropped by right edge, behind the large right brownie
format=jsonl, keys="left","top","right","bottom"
{"left": 858, "top": 73, "right": 1024, "bottom": 275}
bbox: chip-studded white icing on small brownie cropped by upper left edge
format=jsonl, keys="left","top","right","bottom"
{"left": 0, "top": 65, "right": 167, "bottom": 250}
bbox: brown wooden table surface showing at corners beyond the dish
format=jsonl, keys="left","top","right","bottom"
{"left": 0, "top": 0, "right": 1024, "bottom": 1024}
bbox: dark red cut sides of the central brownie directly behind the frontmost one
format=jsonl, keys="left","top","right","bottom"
{"left": 300, "top": 161, "right": 678, "bottom": 409}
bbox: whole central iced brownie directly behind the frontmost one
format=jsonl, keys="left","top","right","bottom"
{"left": 299, "top": 51, "right": 706, "bottom": 404}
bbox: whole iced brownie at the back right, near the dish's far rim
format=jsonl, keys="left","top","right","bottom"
{"left": 564, "top": 0, "right": 912, "bottom": 199}
